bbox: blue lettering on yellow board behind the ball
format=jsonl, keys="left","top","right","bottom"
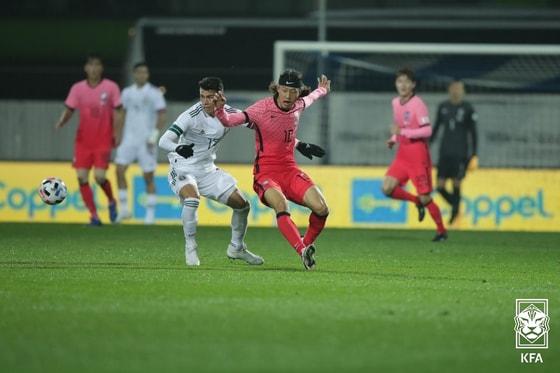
{"left": 0, "top": 181, "right": 107, "bottom": 219}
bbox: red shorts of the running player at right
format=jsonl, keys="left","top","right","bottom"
{"left": 385, "top": 159, "right": 433, "bottom": 194}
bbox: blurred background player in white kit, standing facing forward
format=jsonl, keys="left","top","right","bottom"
{"left": 115, "top": 62, "right": 166, "bottom": 224}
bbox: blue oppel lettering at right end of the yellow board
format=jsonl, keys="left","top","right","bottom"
{"left": 461, "top": 189, "right": 554, "bottom": 227}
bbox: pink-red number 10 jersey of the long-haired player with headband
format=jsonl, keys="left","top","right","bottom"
{"left": 215, "top": 87, "right": 327, "bottom": 174}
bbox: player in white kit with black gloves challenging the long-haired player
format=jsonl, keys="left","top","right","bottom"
{"left": 159, "top": 77, "right": 264, "bottom": 266}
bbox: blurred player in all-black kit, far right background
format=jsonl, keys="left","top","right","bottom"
{"left": 430, "top": 81, "right": 478, "bottom": 224}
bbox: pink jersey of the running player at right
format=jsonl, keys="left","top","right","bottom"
{"left": 392, "top": 96, "right": 432, "bottom": 158}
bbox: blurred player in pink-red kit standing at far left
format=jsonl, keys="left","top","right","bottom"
{"left": 55, "top": 54, "right": 123, "bottom": 226}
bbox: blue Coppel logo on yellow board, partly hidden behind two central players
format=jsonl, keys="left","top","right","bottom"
{"left": 132, "top": 176, "right": 309, "bottom": 223}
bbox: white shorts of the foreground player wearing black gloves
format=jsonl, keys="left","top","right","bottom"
{"left": 167, "top": 167, "right": 237, "bottom": 204}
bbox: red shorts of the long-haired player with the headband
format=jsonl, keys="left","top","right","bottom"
{"left": 253, "top": 167, "right": 315, "bottom": 206}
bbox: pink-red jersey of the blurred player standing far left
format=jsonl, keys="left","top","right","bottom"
{"left": 64, "top": 79, "right": 121, "bottom": 149}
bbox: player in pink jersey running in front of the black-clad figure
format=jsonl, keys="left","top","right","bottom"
{"left": 383, "top": 69, "right": 447, "bottom": 242}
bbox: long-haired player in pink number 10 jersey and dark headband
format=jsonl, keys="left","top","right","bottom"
{"left": 215, "top": 70, "right": 331, "bottom": 269}
